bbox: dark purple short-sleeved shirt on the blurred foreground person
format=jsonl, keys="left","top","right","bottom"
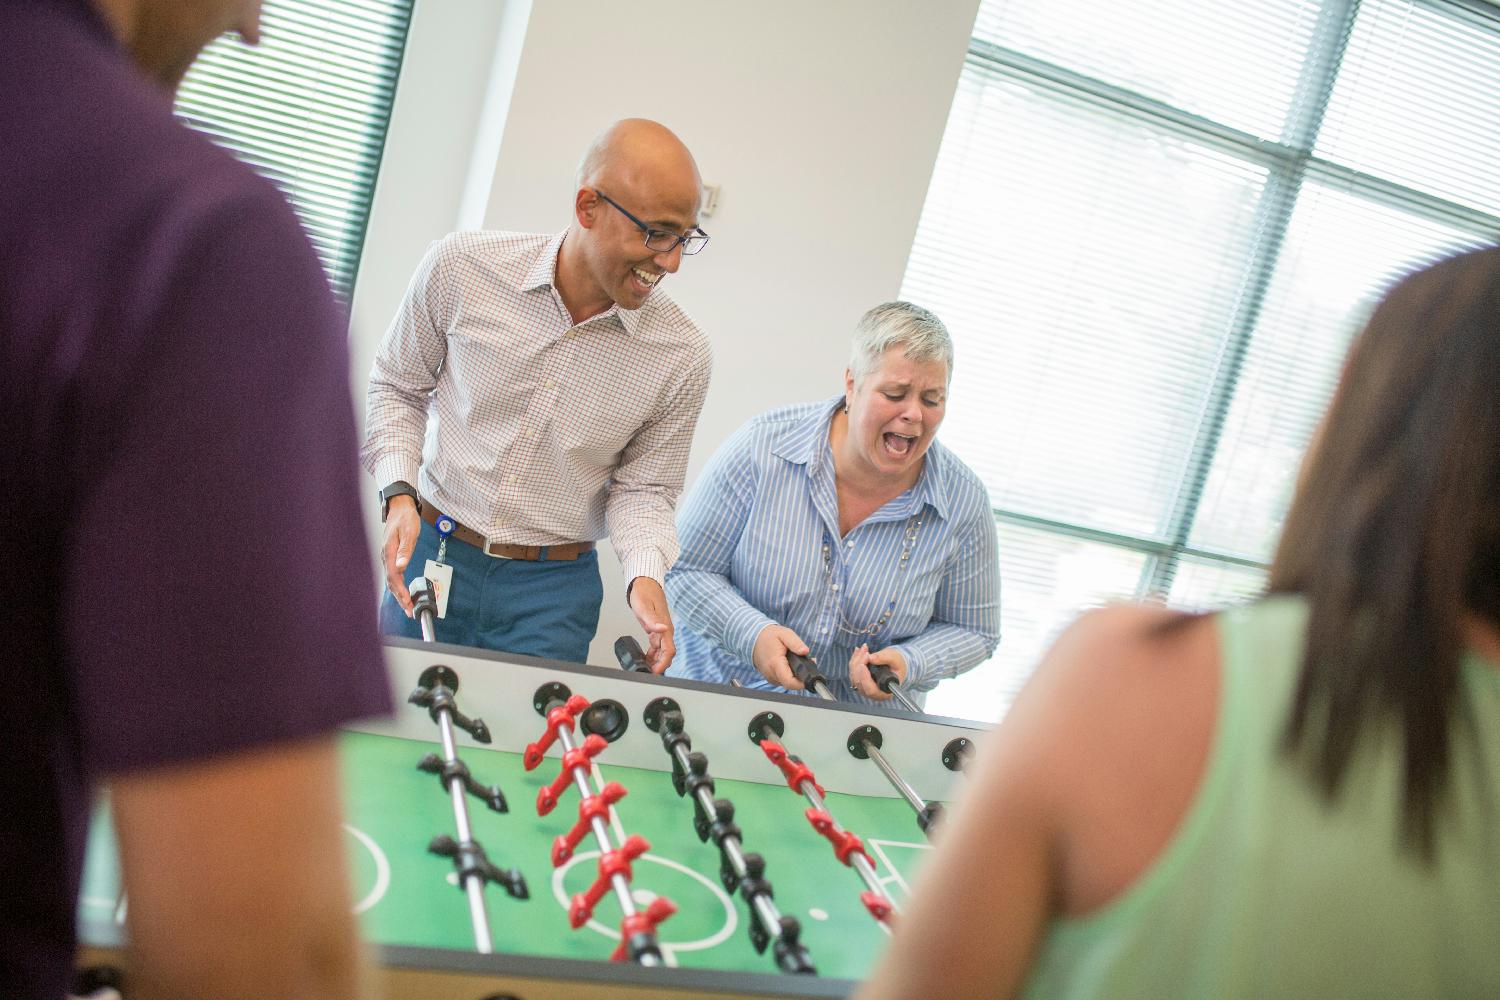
{"left": 0, "top": 0, "right": 390, "bottom": 1000}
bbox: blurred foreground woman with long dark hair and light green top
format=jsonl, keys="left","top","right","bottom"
{"left": 860, "top": 249, "right": 1500, "bottom": 1000}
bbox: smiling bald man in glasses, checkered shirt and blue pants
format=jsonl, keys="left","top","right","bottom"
{"left": 363, "top": 118, "right": 711, "bottom": 673}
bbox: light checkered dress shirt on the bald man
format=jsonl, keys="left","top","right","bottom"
{"left": 362, "top": 232, "right": 711, "bottom": 582}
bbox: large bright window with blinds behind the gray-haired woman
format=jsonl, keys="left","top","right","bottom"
{"left": 902, "top": 0, "right": 1500, "bottom": 720}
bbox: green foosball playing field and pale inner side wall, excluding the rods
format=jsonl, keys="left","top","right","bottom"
{"left": 80, "top": 643, "right": 975, "bottom": 996}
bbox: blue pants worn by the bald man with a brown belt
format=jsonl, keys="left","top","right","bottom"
{"left": 380, "top": 522, "right": 605, "bottom": 663}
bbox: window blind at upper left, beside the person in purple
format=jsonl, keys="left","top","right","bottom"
{"left": 177, "top": 0, "right": 413, "bottom": 301}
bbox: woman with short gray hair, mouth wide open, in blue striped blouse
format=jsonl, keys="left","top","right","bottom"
{"left": 666, "top": 301, "right": 1001, "bottom": 702}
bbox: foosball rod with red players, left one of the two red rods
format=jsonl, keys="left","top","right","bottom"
{"left": 524, "top": 682, "right": 675, "bottom": 966}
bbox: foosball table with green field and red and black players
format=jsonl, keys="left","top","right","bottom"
{"left": 80, "top": 639, "right": 981, "bottom": 1000}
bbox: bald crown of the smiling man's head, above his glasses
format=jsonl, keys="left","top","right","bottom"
{"left": 576, "top": 118, "right": 702, "bottom": 202}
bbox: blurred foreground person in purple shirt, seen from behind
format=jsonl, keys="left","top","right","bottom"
{"left": 0, "top": 0, "right": 390, "bottom": 1000}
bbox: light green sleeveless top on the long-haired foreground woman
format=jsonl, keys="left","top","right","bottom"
{"left": 1025, "top": 597, "right": 1500, "bottom": 1000}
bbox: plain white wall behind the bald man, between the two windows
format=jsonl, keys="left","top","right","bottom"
{"left": 354, "top": 0, "right": 978, "bottom": 664}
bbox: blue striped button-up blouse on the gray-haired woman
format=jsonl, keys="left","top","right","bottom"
{"left": 666, "top": 396, "right": 1001, "bottom": 702}
